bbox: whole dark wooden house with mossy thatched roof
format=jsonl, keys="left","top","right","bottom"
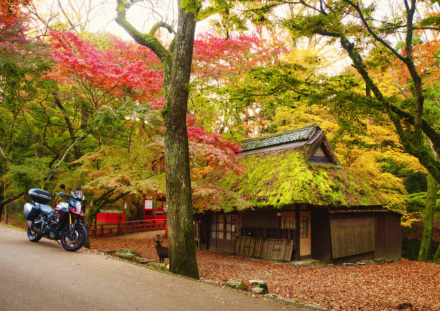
{"left": 194, "top": 124, "right": 401, "bottom": 264}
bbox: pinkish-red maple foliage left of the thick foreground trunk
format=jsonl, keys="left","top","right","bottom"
{"left": 47, "top": 32, "right": 164, "bottom": 108}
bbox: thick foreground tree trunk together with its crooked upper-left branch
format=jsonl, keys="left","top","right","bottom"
{"left": 116, "top": 0, "right": 200, "bottom": 279}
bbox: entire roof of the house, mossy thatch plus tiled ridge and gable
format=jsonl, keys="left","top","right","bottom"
{"left": 224, "top": 124, "right": 381, "bottom": 208}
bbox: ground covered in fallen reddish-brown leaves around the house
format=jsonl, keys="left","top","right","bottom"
{"left": 90, "top": 231, "right": 440, "bottom": 311}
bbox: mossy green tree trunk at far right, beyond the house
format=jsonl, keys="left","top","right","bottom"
{"left": 418, "top": 173, "right": 439, "bottom": 261}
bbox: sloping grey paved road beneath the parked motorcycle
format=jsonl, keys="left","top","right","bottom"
{"left": 0, "top": 225, "right": 310, "bottom": 311}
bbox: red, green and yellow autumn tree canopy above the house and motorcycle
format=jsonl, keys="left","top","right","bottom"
{"left": 0, "top": 0, "right": 440, "bottom": 264}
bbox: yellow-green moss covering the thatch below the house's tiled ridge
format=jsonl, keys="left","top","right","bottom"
{"left": 223, "top": 150, "right": 380, "bottom": 208}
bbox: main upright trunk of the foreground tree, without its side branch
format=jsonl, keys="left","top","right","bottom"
{"left": 163, "top": 3, "right": 199, "bottom": 279}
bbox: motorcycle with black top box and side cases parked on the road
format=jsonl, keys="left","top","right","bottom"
{"left": 23, "top": 184, "right": 87, "bottom": 252}
